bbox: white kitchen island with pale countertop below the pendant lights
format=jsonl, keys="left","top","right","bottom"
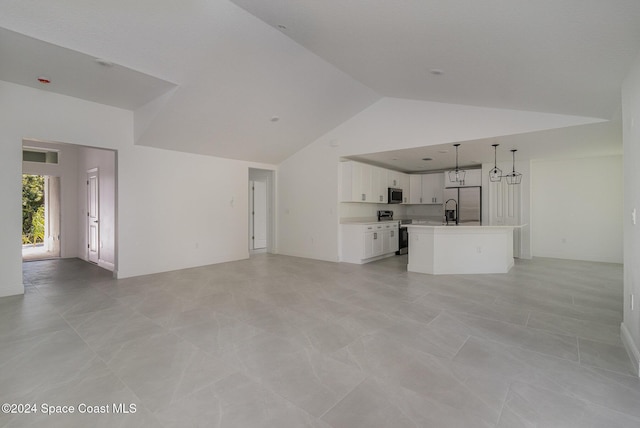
{"left": 407, "top": 224, "right": 521, "bottom": 275}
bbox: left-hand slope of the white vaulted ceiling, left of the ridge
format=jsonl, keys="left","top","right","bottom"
{"left": 0, "top": 0, "right": 380, "bottom": 164}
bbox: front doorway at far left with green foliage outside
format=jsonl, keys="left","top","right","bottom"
{"left": 22, "top": 174, "right": 60, "bottom": 261}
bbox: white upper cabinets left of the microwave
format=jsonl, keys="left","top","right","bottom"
{"left": 340, "top": 161, "right": 388, "bottom": 204}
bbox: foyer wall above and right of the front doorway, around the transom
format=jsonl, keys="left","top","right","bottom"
{"left": 22, "top": 141, "right": 78, "bottom": 258}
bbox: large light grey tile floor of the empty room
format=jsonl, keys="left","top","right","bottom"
{"left": 0, "top": 254, "right": 640, "bottom": 428}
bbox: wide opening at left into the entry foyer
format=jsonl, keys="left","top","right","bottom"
{"left": 22, "top": 140, "right": 117, "bottom": 275}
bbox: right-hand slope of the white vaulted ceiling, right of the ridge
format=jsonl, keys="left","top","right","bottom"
{"left": 232, "top": 0, "right": 640, "bottom": 119}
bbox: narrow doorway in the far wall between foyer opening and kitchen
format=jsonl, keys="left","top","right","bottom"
{"left": 249, "top": 168, "right": 274, "bottom": 254}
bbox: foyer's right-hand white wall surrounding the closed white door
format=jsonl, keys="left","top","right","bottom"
{"left": 76, "top": 147, "right": 116, "bottom": 270}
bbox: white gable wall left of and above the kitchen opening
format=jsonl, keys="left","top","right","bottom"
{"left": 278, "top": 98, "right": 600, "bottom": 261}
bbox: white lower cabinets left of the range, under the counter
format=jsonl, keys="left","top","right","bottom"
{"left": 340, "top": 222, "right": 399, "bottom": 264}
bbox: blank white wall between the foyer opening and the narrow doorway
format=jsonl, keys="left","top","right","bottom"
{"left": 118, "top": 147, "right": 256, "bottom": 277}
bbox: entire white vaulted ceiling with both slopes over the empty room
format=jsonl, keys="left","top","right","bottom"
{"left": 0, "top": 0, "right": 640, "bottom": 164}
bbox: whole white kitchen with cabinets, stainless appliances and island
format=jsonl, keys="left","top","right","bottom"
{"left": 339, "top": 156, "right": 520, "bottom": 274}
